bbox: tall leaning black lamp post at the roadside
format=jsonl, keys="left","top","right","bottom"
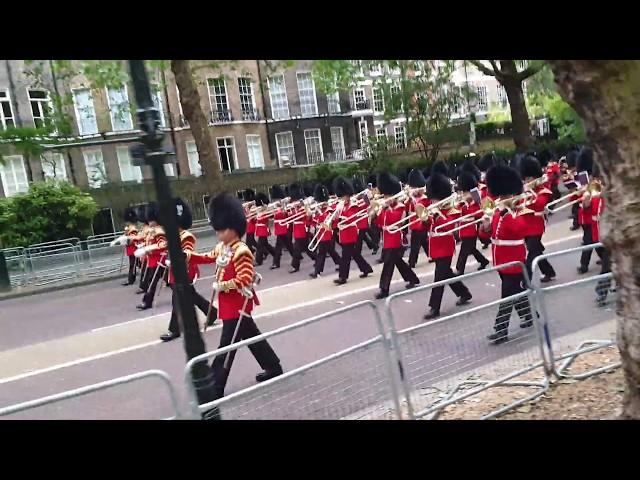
{"left": 129, "top": 60, "right": 217, "bottom": 419}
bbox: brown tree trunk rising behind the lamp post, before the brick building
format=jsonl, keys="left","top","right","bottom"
{"left": 171, "top": 60, "right": 222, "bottom": 185}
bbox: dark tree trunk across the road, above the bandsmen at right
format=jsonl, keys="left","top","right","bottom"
{"left": 500, "top": 60, "right": 533, "bottom": 153}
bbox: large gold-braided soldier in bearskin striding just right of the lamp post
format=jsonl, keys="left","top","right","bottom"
{"left": 189, "top": 194, "right": 282, "bottom": 398}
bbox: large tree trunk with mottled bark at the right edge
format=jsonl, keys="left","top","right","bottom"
{"left": 549, "top": 60, "right": 640, "bottom": 419}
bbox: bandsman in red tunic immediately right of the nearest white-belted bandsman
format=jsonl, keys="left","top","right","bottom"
{"left": 520, "top": 155, "right": 556, "bottom": 283}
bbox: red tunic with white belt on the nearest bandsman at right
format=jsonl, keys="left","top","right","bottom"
{"left": 491, "top": 210, "right": 527, "bottom": 274}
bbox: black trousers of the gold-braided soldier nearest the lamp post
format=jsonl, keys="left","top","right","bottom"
{"left": 211, "top": 317, "right": 280, "bottom": 396}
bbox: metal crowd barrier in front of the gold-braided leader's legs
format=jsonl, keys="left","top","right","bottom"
{"left": 185, "top": 301, "right": 401, "bottom": 419}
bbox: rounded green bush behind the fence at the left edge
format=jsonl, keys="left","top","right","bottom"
{"left": 0, "top": 182, "right": 98, "bottom": 247}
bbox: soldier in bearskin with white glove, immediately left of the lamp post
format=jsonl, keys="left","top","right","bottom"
{"left": 134, "top": 202, "right": 167, "bottom": 310}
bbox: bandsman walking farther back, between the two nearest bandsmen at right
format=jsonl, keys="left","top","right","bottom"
{"left": 456, "top": 170, "right": 489, "bottom": 275}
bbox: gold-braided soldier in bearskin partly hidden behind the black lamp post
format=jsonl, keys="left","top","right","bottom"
{"left": 160, "top": 198, "right": 217, "bottom": 342}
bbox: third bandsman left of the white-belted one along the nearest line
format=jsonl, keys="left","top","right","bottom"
{"left": 333, "top": 177, "right": 373, "bottom": 285}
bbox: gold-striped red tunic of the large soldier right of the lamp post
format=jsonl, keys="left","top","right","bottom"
{"left": 190, "top": 240, "right": 259, "bottom": 321}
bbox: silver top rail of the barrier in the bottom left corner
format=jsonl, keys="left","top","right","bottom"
{"left": 0, "top": 370, "right": 181, "bottom": 420}
